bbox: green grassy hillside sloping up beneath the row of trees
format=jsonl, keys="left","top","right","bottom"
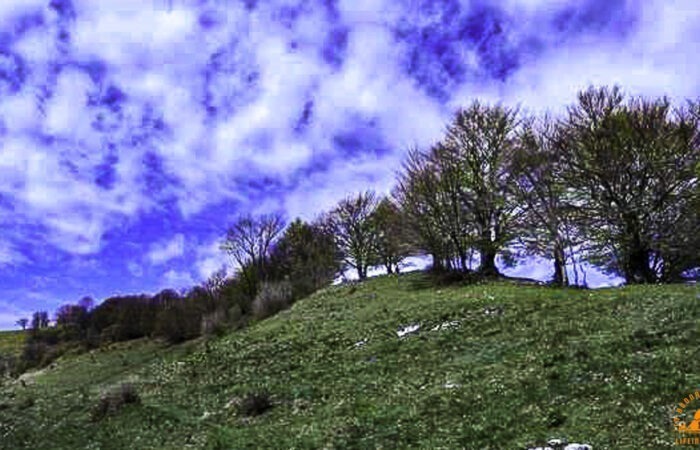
{"left": 0, "top": 274, "right": 700, "bottom": 450}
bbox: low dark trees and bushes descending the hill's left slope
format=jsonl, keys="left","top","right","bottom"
{"left": 12, "top": 215, "right": 341, "bottom": 370}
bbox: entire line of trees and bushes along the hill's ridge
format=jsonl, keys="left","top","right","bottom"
{"left": 12, "top": 88, "right": 700, "bottom": 370}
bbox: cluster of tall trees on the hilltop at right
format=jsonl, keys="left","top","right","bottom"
{"left": 394, "top": 88, "right": 700, "bottom": 285}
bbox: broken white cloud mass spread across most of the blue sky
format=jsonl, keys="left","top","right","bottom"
{"left": 0, "top": 0, "right": 700, "bottom": 312}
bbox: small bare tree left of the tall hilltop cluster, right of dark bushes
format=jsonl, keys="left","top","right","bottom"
{"left": 324, "top": 191, "right": 378, "bottom": 280}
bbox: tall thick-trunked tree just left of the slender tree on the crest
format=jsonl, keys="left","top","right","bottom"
{"left": 446, "top": 102, "right": 518, "bottom": 275}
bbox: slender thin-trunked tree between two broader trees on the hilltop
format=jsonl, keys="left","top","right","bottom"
{"left": 509, "top": 118, "right": 574, "bottom": 286}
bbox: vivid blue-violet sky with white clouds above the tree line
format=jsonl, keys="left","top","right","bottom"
{"left": 0, "top": 0, "right": 700, "bottom": 329}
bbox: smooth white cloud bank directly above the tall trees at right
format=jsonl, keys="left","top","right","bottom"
{"left": 452, "top": 0, "right": 700, "bottom": 114}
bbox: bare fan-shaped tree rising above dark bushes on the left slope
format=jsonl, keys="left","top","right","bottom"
{"left": 221, "top": 214, "right": 284, "bottom": 297}
